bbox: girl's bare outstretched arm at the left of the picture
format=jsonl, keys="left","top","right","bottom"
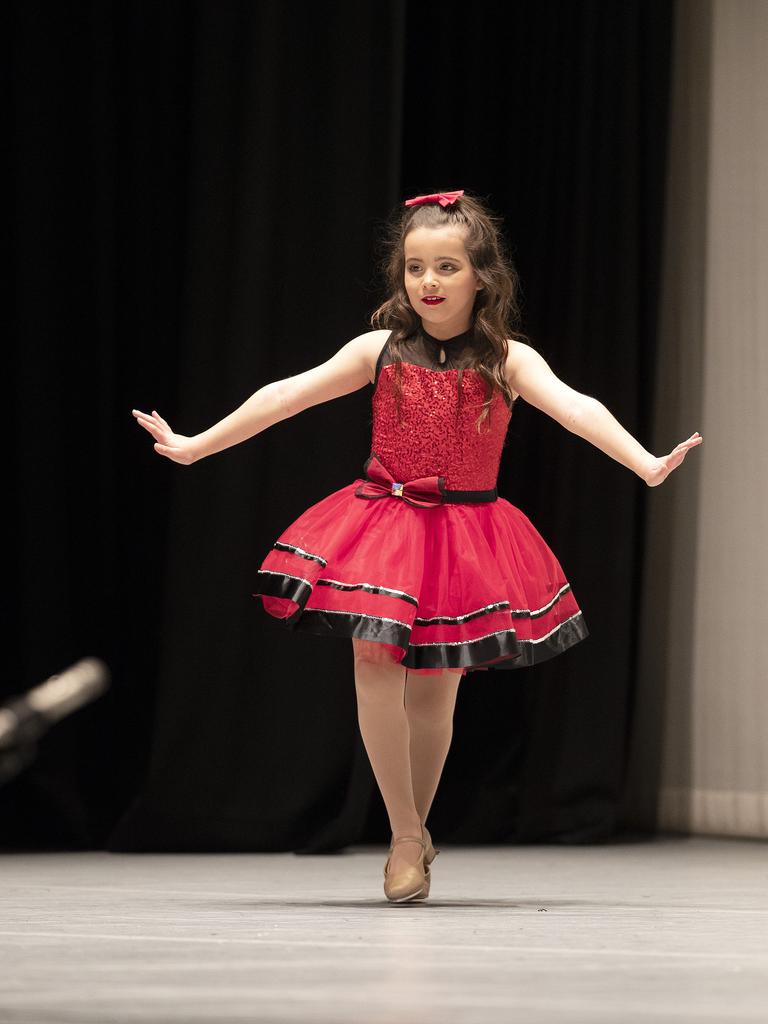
{"left": 131, "top": 331, "right": 389, "bottom": 466}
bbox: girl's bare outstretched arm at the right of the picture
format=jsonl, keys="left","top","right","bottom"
{"left": 506, "top": 341, "right": 703, "bottom": 487}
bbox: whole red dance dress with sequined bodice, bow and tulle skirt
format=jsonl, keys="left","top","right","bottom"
{"left": 253, "top": 329, "right": 589, "bottom": 675}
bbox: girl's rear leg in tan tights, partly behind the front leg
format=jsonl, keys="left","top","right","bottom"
{"left": 406, "top": 670, "right": 462, "bottom": 823}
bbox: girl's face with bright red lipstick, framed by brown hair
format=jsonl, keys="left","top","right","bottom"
{"left": 404, "top": 227, "right": 482, "bottom": 338}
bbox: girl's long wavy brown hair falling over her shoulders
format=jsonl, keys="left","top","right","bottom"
{"left": 370, "top": 191, "right": 529, "bottom": 433}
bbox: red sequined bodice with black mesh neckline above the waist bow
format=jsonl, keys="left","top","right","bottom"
{"left": 371, "top": 334, "right": 512, "bottom": 490}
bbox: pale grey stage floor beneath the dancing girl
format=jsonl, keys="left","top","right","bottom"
{"left": 0, "top": 836, "right": 768, "bottom": 1024}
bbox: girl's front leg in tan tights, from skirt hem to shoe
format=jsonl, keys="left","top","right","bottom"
{"left": 352, "top": 638, "right": 422, "bottom": 870}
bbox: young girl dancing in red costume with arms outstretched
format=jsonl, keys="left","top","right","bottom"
{"left": 133, "top": 189, "right": 702, "bottom": 902}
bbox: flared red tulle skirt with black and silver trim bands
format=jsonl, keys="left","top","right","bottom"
{"left": 253, "top": 471, "right": 589, "bottom": 675}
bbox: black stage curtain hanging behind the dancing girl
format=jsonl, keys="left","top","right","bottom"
{"left": 0, "top": 0, "right": 673, "bottom": 853}
